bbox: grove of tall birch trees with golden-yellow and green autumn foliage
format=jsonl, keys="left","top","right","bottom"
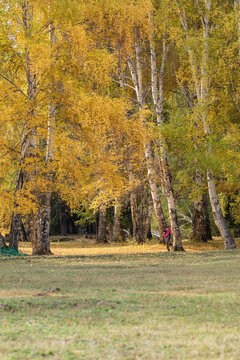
{"left": 0, "top": 0, "right": 240, "bottom": 254}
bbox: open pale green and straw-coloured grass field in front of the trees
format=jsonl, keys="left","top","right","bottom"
{"left": 0, "top": 251, "right": 240, "bottom": 360}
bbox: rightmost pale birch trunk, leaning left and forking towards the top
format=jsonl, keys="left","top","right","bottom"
{"left": 172, "top": 0, "right": 236, "bottom": 249}
